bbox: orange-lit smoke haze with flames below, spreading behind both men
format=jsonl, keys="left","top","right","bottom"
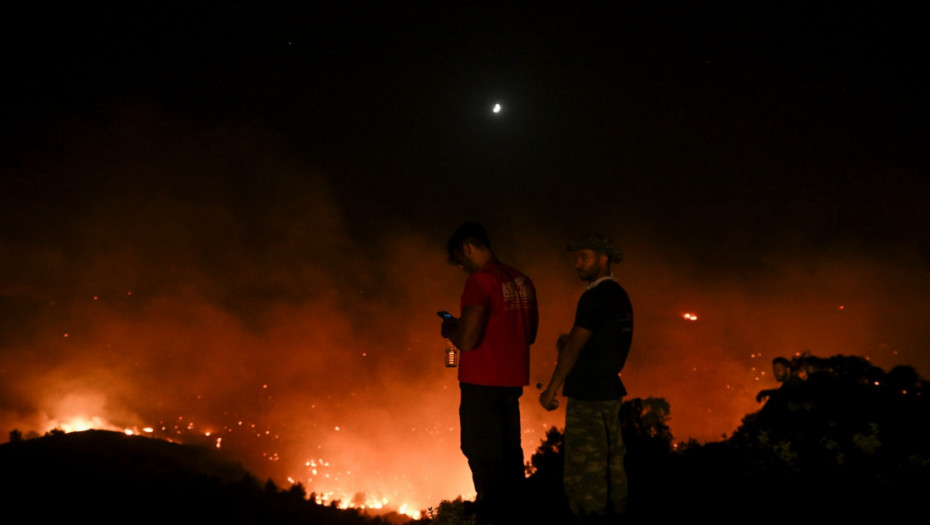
{"left": 0, "top": 118, "right": 930, "bottom": 509}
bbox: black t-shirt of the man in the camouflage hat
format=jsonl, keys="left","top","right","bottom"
{"left": 562, "top": 279, "right": 633, "bottom": 401}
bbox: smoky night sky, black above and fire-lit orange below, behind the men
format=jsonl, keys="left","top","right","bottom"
{"left": 0, "top": 2, "right": 930, "bottom": 508}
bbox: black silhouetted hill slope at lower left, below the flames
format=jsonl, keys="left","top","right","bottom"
{"left": 0, "top": 430, "right": 410, "bottom": 525}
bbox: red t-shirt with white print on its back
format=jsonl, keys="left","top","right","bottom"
{"left": 459, "top": 263, "right": 539, "bottom": 386}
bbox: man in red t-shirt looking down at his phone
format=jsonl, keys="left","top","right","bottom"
{"left": 442, "top": 223, "right": 539, "bottom": 523}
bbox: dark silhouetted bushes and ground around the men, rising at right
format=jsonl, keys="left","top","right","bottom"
{"left": 439, "top": 355, "right": 930, "bottom": 524}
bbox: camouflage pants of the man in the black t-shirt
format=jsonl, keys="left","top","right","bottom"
{"left": 563, "top": 398, "right": 627, "bottom": 516}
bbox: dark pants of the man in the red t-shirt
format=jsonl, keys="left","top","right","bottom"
{"left": 459, "top": 383, "right": 524, "bottom": 523}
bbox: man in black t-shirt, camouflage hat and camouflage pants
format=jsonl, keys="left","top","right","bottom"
{"left": 539, "top": 235, "right": 633, "bottom": 521}
